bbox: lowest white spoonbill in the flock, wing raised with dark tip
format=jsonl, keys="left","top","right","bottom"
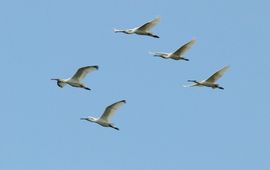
{"left": 81, "top": 100, "right": 126, "bottom": 130}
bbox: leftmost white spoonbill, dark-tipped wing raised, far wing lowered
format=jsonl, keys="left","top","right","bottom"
{"left": 51, "top": 66, "right": 98, "bottom": 90}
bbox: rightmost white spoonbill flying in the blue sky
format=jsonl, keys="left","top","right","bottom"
{"left": 184, "top": 66, "right": 229, "bottom": 90}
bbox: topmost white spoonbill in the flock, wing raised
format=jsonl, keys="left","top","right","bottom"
{"left": 114, "top": 17, "right": 160, "bottom": 38}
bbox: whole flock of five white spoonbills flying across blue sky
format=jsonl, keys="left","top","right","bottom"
{"left": 51, "top": 17, "right": 229, "bottom": 130}
